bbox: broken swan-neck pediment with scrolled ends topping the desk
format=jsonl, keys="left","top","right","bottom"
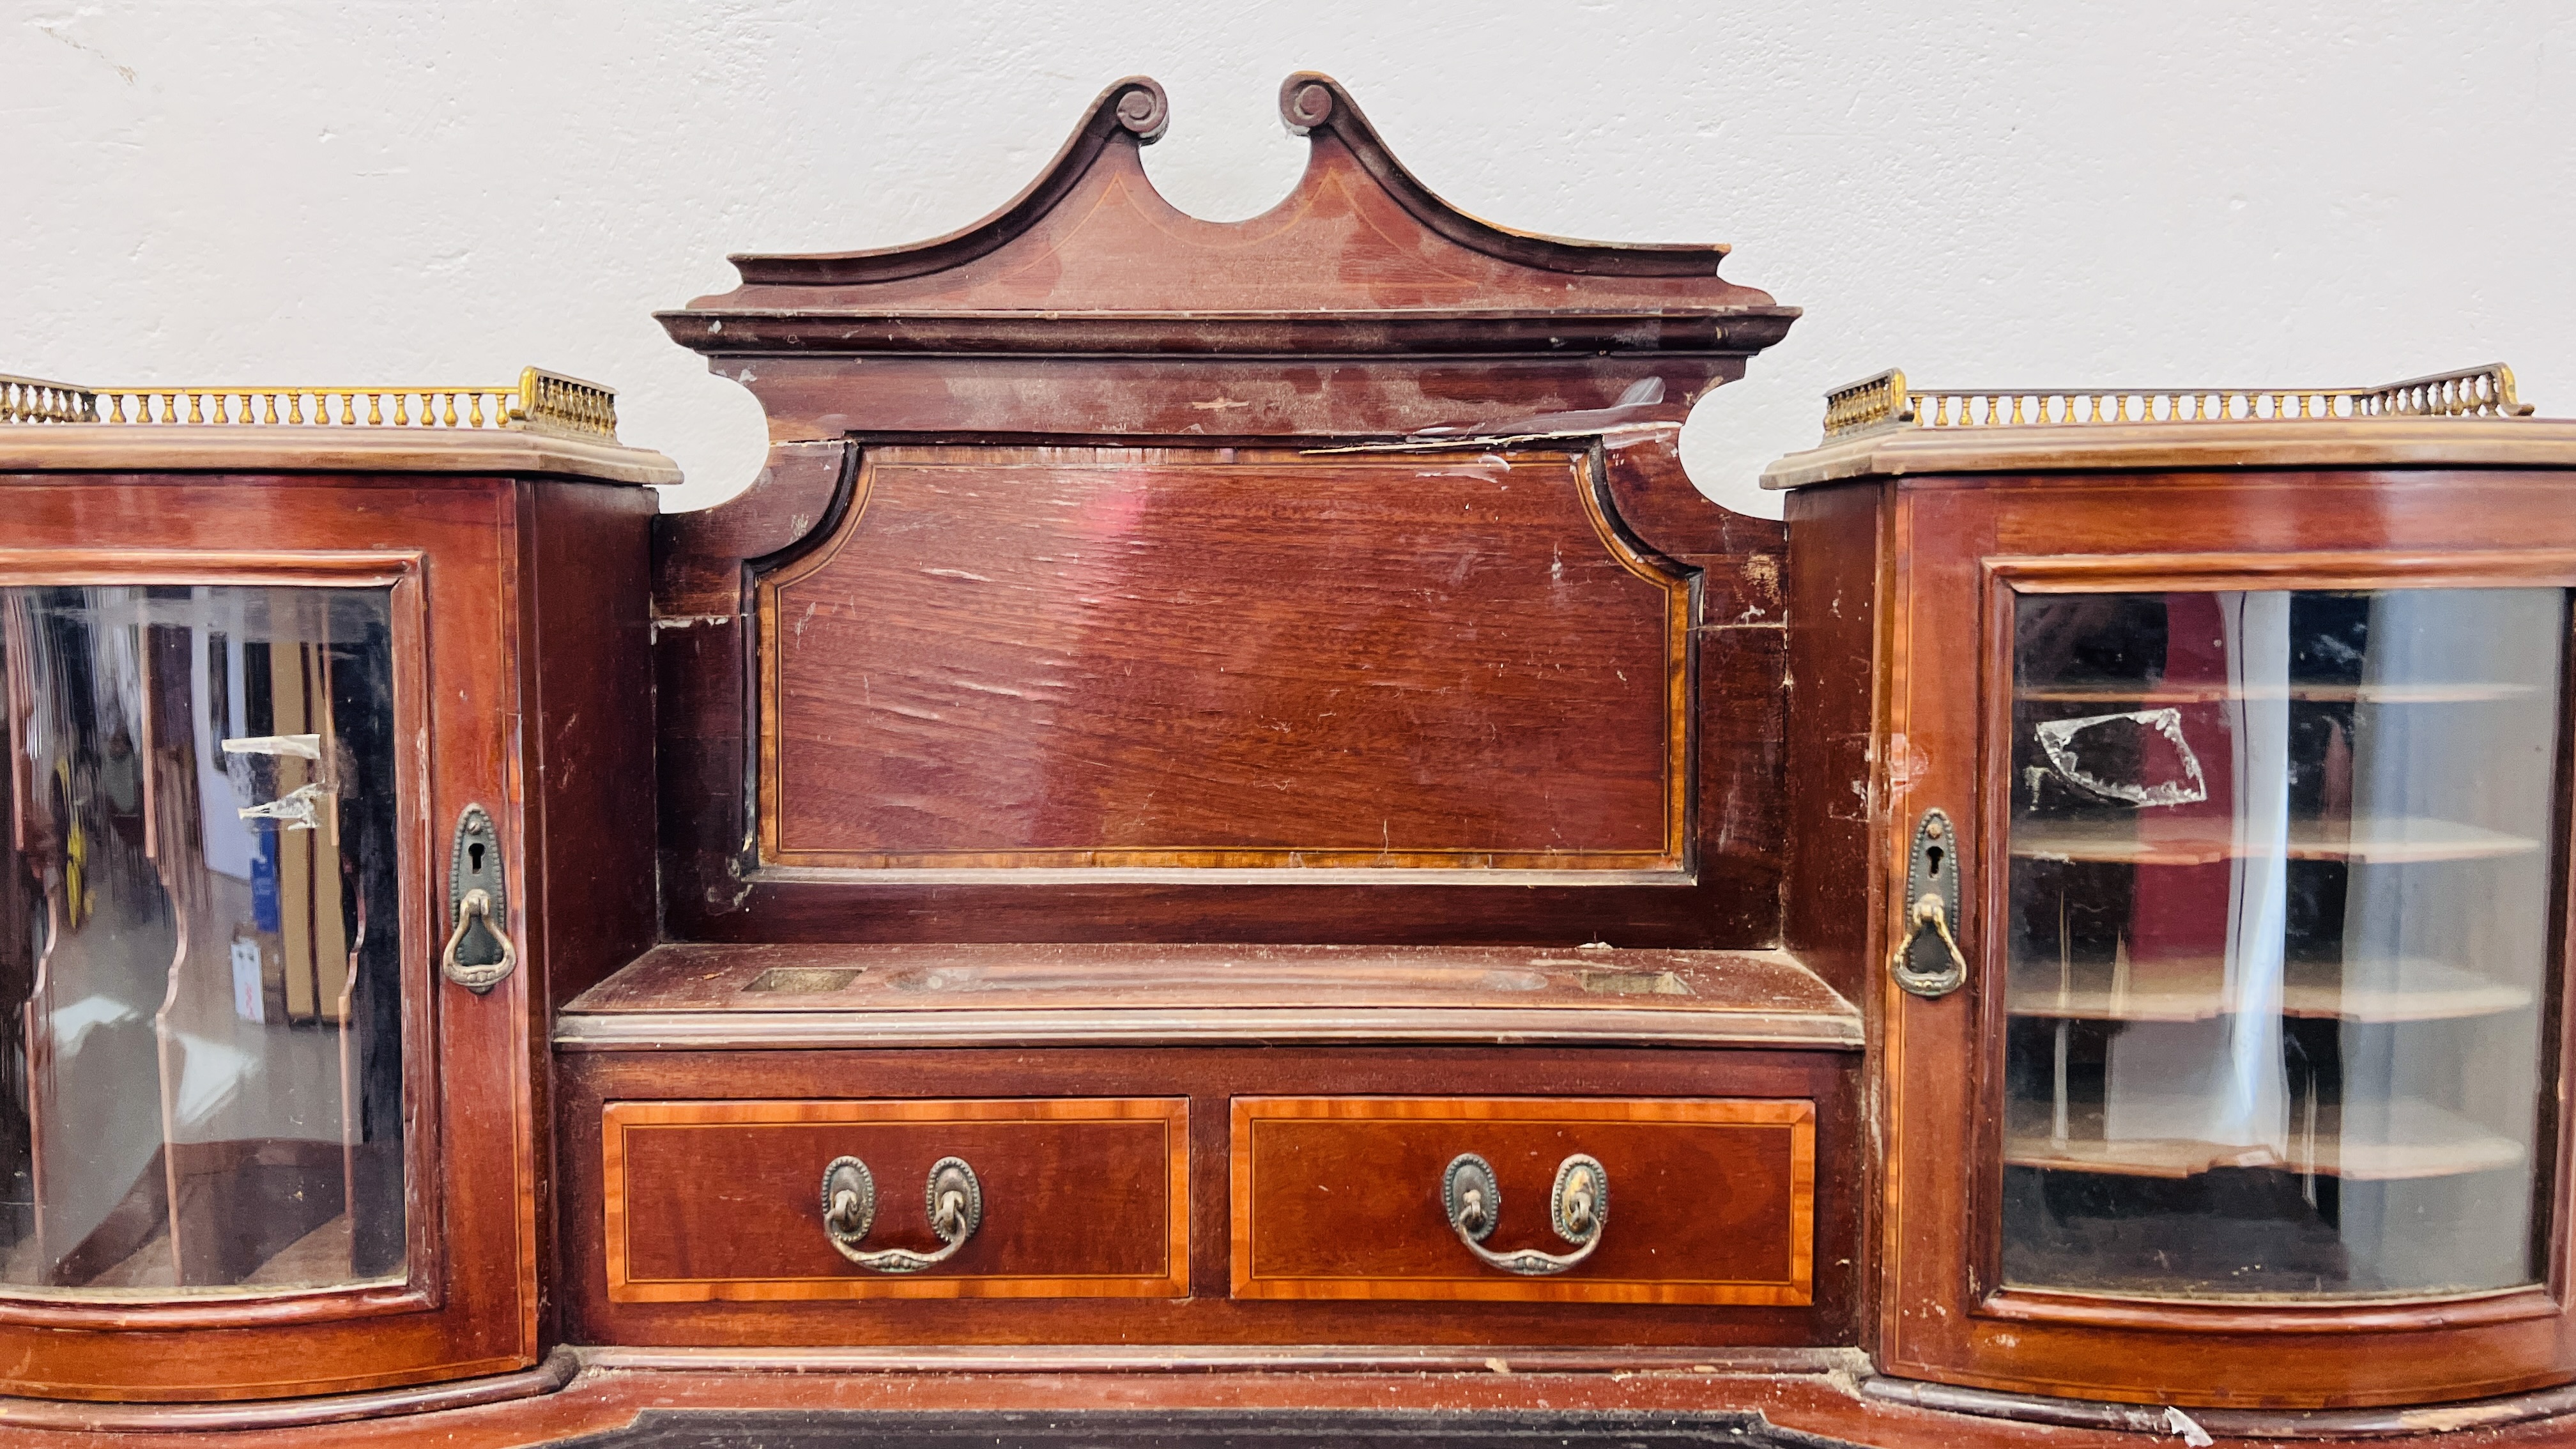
{"left": 659, "top": 72, "right": 1798, "bottom": 358}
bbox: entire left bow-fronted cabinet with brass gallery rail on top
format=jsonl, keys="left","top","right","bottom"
{"left": 0, "top": 371, "right": 675, "bottom": 1400}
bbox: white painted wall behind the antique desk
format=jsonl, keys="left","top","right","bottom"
{"left": 0, "top": 0, "right": 2576, "bottom": 508}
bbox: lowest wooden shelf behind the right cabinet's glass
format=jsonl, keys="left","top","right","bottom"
{"left": 2004, "top": 1098, "right": 2524, "bottom": 1181}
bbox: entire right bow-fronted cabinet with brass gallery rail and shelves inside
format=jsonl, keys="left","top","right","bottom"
{"left": 1767, "top": 369, "right": 2576, "bottom": 1407}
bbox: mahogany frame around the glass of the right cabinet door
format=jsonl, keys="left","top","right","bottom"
{"left": 1875, "top": 469, "right": 2576, "bottom": 1407}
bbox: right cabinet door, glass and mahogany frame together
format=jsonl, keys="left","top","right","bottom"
{"left": 1885, "top": 480, "right": 2576, "bottom": 1405}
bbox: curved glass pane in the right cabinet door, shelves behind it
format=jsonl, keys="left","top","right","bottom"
{"left": 2002, "top": 588, "right": 2568, "bottom": 1300}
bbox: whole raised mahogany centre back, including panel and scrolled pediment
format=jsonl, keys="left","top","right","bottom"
{"left": 654, "top": 75, "right": 1795, "bottom": 949}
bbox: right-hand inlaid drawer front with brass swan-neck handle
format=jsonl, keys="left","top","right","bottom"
{"left": 1231, "top": 1096, "right": 1816, "bottom": 1305}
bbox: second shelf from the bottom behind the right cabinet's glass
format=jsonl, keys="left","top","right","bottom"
{"left": 2004, "top": 956, "right": 2532, "bottom": 1021}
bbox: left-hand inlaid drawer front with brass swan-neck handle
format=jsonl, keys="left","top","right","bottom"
{"left": 602, "top": 1098, "right": 1190, "bottom": 1302}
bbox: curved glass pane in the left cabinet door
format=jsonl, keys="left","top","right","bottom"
{"left": 0, "top": 585, "right": 404, "bottom": 1297}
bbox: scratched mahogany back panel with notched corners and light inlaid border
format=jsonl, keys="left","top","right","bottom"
{"left": 757, "top": 446, "right": 1692, "bottom": 879}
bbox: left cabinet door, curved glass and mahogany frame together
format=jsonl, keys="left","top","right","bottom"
{"left": 0, "top": 479, "right": 533, "bottom": 1397}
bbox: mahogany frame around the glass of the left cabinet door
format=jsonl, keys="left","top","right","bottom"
{"left": 0, "top": 475, "right": 544, "bottom": 1400}
